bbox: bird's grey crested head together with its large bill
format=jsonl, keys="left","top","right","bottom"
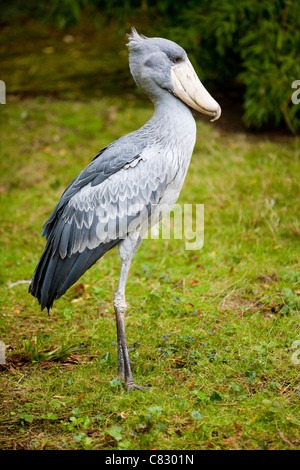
{"left": 127, "top": 28, "right": 221, "bottom": 121}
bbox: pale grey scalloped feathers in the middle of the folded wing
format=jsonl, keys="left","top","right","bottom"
{"left": 59, "top": 150, "right": 173, "bottom": 257}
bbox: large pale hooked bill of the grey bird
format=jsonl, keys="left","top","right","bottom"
{"left": 171, "top": 59, "right": 221, "bottom": 121}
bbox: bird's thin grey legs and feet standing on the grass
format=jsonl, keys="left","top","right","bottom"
{"left": 114, "top": 237, "right": 142, "bottom": 390}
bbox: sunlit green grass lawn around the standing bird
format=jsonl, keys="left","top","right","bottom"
{"left": 0, "top": 17, "right": 300, "bottom": 450}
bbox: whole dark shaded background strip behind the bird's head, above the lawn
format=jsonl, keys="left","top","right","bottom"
{"left": 0, "top": 0, "right": 300, "bottom": 134}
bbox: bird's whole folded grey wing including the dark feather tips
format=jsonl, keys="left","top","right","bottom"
{"left": 29, "top": 140, "right": 178, "bottom": 310}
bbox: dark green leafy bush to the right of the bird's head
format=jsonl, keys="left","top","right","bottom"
{"left": 165, "top": 0, "right": 300, "bottom": 133}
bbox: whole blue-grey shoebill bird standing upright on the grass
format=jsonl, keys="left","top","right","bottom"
{"left": 29, "top": 27, "right": 221, "bottom": 391}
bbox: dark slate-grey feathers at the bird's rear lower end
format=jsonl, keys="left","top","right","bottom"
{"left": 29, "top": 239, "right": 119, "bottom": 311}
